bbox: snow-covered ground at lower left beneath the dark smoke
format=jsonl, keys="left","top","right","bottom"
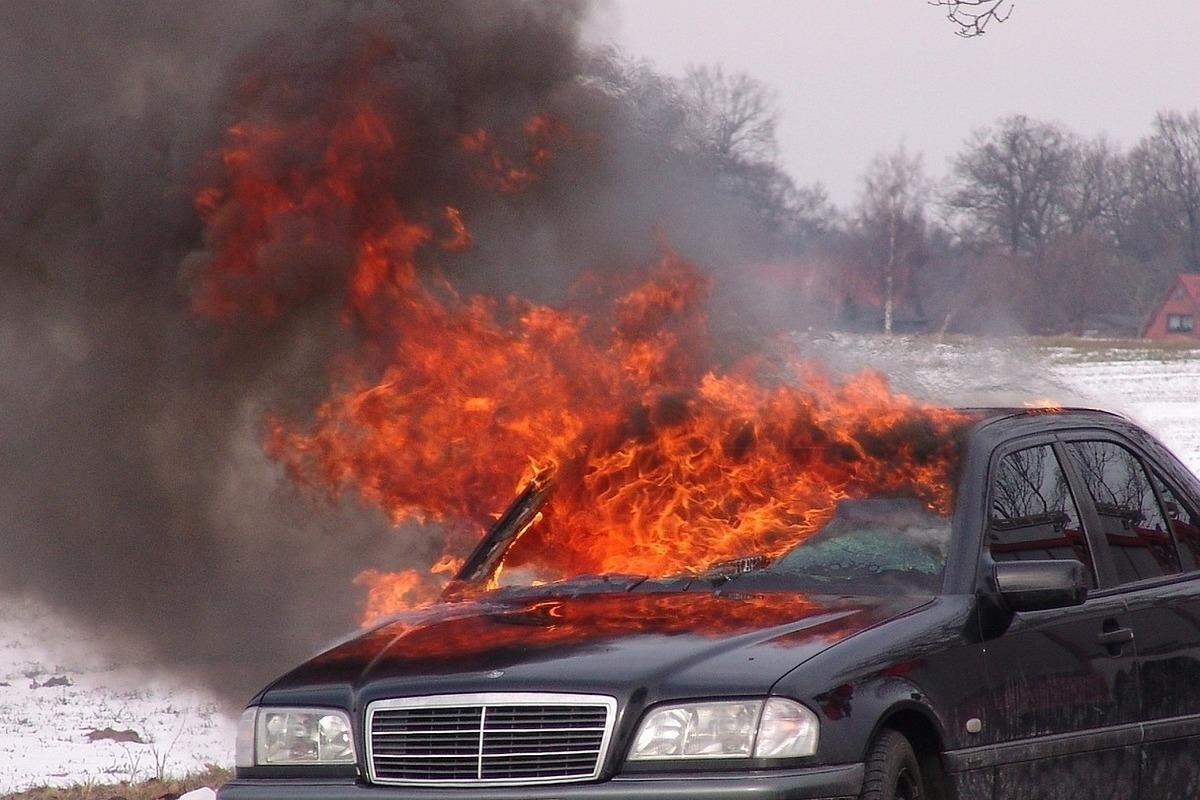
{"left": 0, "top": 597, "right": 236, "bottom": 793}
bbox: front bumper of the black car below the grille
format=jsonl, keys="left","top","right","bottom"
{"left": 217, "top": 764, "right": 864, "bottom": 800}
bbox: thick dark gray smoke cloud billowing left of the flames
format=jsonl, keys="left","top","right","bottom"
{"left": 0, "top": 0, "right": 782, "bottom": 705}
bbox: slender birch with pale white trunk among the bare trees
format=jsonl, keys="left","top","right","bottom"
{"left": 858, "top": 146, "right": 930, "bottom": 335}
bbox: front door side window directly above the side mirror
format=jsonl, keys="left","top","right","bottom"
{"left": 988, "top": 445, "right": 1096, "bottom": 587}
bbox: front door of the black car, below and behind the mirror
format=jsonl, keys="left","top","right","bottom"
{"left": 982, "top": 437, "right": 1140, "bottom": 800}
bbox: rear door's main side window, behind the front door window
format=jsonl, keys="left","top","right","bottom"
{"left": 1067, "top": 441, "right": 1182, "bottom": 583}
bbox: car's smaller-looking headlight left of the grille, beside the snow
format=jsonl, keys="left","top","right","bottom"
{"left": 235, "top": 705, "right": 355, "bottom": 766}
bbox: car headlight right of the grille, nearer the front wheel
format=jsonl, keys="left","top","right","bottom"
{"left": 629, "top": 697, "right": 820, "bottom": 760}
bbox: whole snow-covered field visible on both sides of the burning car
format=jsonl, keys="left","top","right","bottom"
{"left": 0, "top": 336, "right": 1200, "bottom": 792}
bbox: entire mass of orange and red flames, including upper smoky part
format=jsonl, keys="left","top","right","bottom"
{"left": 187, "top": 9, "right": 964, "bottom": 620}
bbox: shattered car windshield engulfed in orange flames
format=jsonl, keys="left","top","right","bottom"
{"left": 446, "top": 417, "right": 970, "bottom": 596}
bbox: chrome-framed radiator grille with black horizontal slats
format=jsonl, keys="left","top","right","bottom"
{"left": 367, "top": 692, "right": 617, "bottom": 786}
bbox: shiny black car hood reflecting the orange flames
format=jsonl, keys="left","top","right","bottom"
{"left": 263, "top": 590, "right": 930, "bottom": 703}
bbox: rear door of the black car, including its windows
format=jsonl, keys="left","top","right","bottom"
{"left": 1064, "top": 437, "right": 1200, "bottom": 800}
